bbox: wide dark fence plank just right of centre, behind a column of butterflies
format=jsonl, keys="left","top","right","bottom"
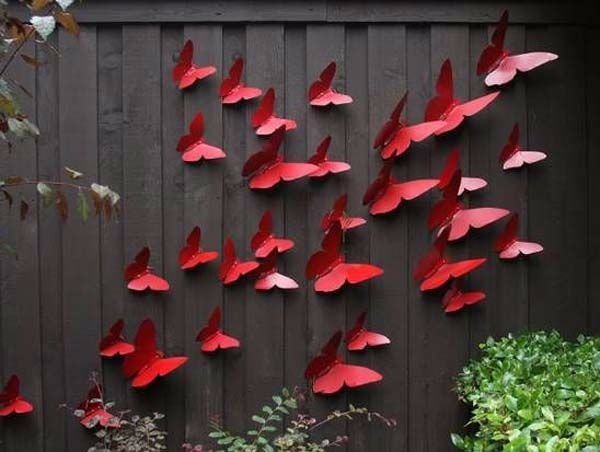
{"left": 298, "top": 24, "right": 347, "bottom": 433}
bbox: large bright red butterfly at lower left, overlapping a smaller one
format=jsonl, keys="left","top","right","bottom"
{"left": 123, "top": 319, "right": 188, "bottom": 388}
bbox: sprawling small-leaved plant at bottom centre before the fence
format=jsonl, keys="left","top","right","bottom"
{"left": 183, "top": 388, "right": 396, "bottom": 452}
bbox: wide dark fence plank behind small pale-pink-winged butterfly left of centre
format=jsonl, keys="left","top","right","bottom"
{"left": 245, "top": 25, "right": 294, "bottom": 417}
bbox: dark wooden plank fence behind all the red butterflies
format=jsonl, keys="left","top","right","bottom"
{"left": 0, "top": 0, "right": 600, "bottom": 452}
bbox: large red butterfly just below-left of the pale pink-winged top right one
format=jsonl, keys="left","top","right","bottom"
{"left": 425, "top": 59, "right": 500, "bottom": 135}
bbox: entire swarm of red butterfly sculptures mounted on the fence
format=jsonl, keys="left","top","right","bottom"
{"left": 0, "top": 11, "right": 558, "bottom": 416}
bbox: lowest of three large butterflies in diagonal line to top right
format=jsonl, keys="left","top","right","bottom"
{"left": 373, "top": 93, "right": 446, "bottom": 160}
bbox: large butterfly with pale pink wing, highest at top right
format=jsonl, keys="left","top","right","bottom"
{"left": 477, "top": 11, "right": 558, "bottom": 86}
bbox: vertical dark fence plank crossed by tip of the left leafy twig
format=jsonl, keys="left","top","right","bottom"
{"left": 97, "top": 27, "right": 128, "bottom": 416}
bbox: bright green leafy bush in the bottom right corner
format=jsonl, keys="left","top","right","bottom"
{"left": 452, "top": 332, "right": 600, "bottom": 452}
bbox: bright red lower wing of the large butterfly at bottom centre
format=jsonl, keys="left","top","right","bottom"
{"left": 312, "top": 363, "right": 383, "bottom": 394}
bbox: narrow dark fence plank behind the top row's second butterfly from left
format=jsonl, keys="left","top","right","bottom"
{"left": 221, "top": 26, "right": 247, "bottom": 431}
